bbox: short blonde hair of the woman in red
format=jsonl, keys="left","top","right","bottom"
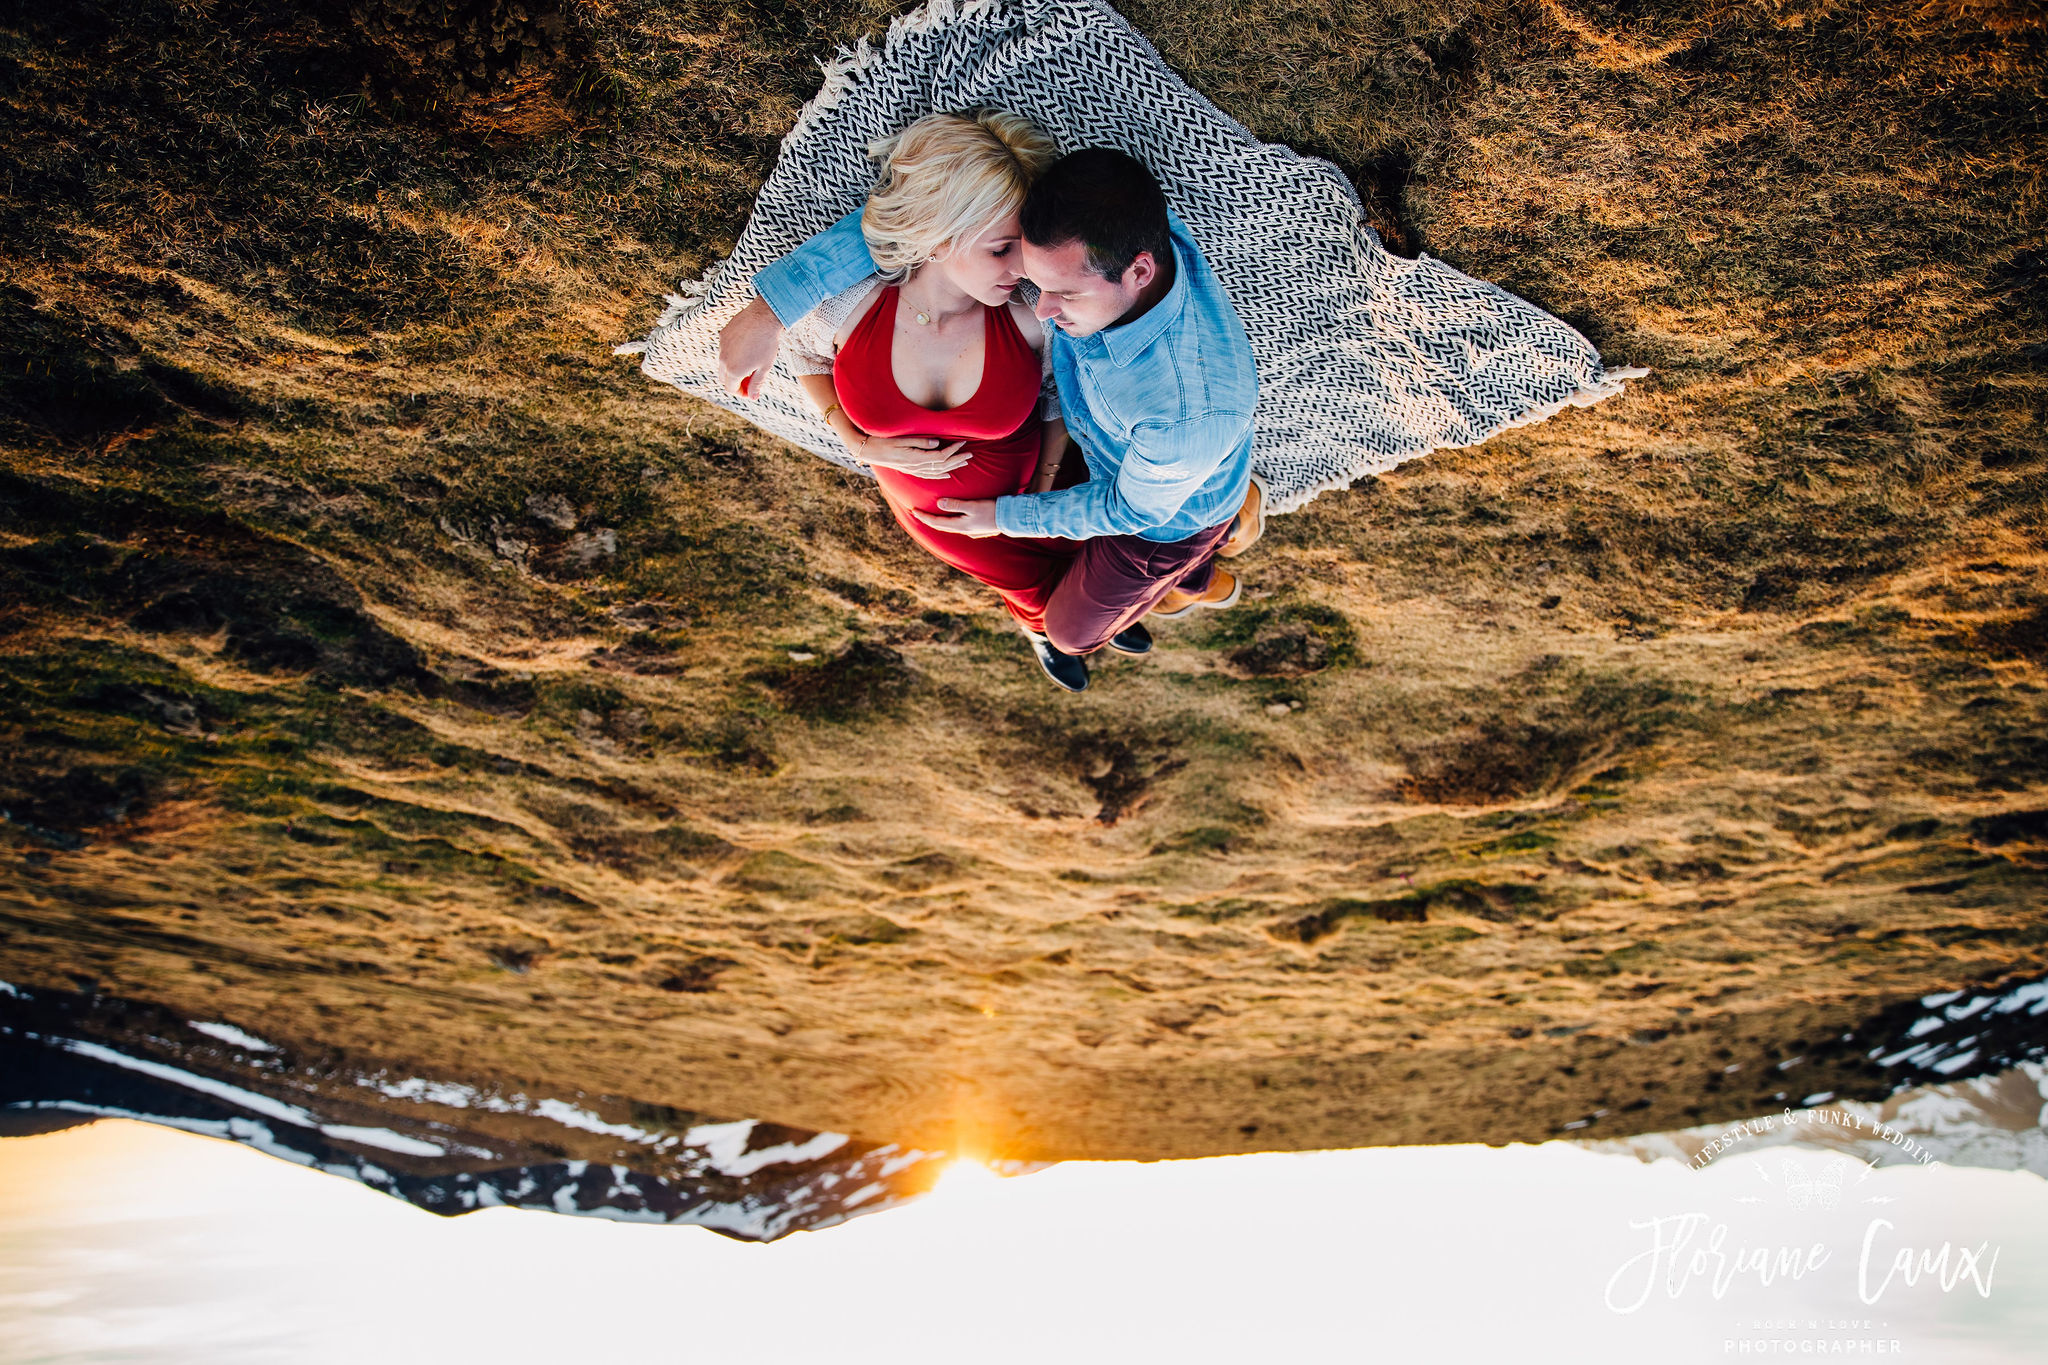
{"left": 860, "top": 108, "right": 1059, "bottom": 284}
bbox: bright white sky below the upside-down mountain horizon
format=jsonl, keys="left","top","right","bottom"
{"left": 0, "top": 1119, "right": 2048, "bottom": 1365}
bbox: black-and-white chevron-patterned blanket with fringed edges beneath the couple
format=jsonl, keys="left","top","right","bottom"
{"left": 618, "top": 0, "right": 1647, "bottom": 512}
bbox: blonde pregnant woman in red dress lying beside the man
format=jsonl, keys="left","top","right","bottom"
{"left": 788, "top": 111, "right": 1087, "bottom": 692}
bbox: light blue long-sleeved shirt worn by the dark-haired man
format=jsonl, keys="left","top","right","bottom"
{"left": 754, "top": 211, "right": 1260, "bottom": 542}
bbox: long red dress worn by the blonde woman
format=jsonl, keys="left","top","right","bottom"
{"left": 831, "top": 284, "right": 1073, "bottom": 632}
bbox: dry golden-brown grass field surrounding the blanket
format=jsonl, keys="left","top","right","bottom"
{"left": 0, "top": 0, "right": 2048, "bottom": 1154}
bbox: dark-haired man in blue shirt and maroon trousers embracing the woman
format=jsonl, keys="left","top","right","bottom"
{"left": 719, "top": 147, "right": 1257, "bottom": 692}
